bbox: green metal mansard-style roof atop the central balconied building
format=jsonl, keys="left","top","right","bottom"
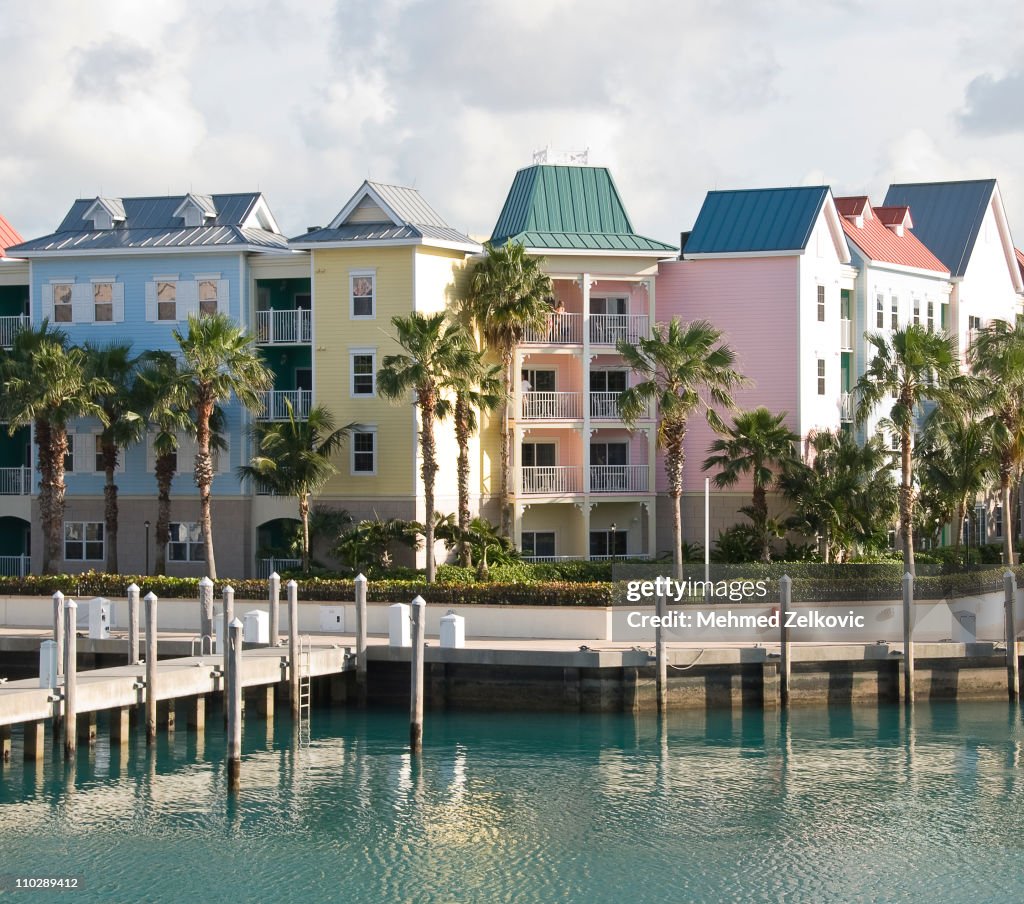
{"left": 490, "top": 164, "right": 678, "bottom": 254}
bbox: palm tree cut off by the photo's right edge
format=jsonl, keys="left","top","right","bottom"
{"left": 970, "top": 320, "right": 1024, "bottom": 567}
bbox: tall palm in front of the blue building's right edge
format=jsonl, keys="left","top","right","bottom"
{"left": 173, "top": 314, "right": 273, "bottom": 580}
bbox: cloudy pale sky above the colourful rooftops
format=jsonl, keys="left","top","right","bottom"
{"left": 0, "top": 0, "right": 1024, "bottom": 245}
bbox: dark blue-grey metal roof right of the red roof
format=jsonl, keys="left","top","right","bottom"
{"left": 885, "top": 179, "right": 995, "bottom": 276}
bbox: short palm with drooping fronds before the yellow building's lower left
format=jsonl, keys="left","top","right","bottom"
{"left": 238, "top": 402, "right": 356, "bottom": 574}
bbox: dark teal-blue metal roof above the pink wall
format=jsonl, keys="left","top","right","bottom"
{"left": 686, "top": 185, "right": 828, "bottom": 255}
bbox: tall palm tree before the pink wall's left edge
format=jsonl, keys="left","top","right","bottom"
{"left": 618, "top": 317, "right": 746, "bottom": 579}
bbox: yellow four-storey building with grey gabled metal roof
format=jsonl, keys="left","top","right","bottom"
{"left": 290, "top": 181, "right": 480, "bottom": 564}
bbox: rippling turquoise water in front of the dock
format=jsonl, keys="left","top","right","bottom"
{"left": 0, "top": 703, "right": 1024, "bottom": 904}
